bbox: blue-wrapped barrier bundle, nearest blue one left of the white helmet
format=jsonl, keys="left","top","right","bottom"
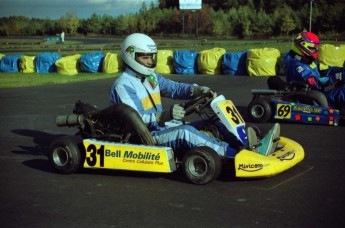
{"left": 79, "top": 51, "right": 104, "bottom": 73}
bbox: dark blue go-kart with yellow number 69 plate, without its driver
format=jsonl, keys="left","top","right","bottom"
{"left": 247, "top": 77, "right": 344, "bottom": 126}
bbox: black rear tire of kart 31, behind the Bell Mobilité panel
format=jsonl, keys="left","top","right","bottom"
{"left": 48, "top": 136, "right": 85, "bottom": 174}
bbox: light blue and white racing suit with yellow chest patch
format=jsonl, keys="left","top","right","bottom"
{"left": 109, "top": 68, "right": 242, "bottom": 157}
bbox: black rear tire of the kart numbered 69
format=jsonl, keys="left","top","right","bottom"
{"left": 247, "top": 97, "right": 273, "bottom": 123}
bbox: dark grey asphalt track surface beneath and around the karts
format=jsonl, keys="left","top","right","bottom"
{"left": 0, "top": 75, "right": 345, "bottom": 228}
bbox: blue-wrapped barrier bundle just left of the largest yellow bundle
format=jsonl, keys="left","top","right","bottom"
{"left": 222, "top": 51, "right": 248, "bottom": 75}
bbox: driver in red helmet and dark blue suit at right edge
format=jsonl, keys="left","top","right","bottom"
{"left": 284, "top": 32, "right": 345, "bottom": 109}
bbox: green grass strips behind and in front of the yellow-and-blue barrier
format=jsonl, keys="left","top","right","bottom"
{"left": 0, "top": 37, "right": 344, "bottom": 88}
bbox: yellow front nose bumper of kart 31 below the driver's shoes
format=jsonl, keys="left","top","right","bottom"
{"left": 235, "top": 137, "right": 304, "bottom": 178}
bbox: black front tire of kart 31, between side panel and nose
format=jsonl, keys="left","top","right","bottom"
{"left": 182, "top": 146, "right": 222, "bottom": 185}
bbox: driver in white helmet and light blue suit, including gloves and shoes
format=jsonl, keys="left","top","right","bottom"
{"left": 109, "top": 33, "right": 280, "bottom": 157}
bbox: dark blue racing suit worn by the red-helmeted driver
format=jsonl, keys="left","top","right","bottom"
{"left": 284, "top": 51, "right": 345, "bottom": 108}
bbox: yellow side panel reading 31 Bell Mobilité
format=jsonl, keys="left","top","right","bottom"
{"left": 83, "top": 139, "right": 176, "bottom": 173}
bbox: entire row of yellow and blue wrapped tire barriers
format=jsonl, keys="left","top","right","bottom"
{"left": 0, "top": 44, "right": 345, "bottom": 76}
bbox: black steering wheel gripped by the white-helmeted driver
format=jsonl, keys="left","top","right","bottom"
{"left": 180, "top": 92, "right": 213, "bottom": 116}
